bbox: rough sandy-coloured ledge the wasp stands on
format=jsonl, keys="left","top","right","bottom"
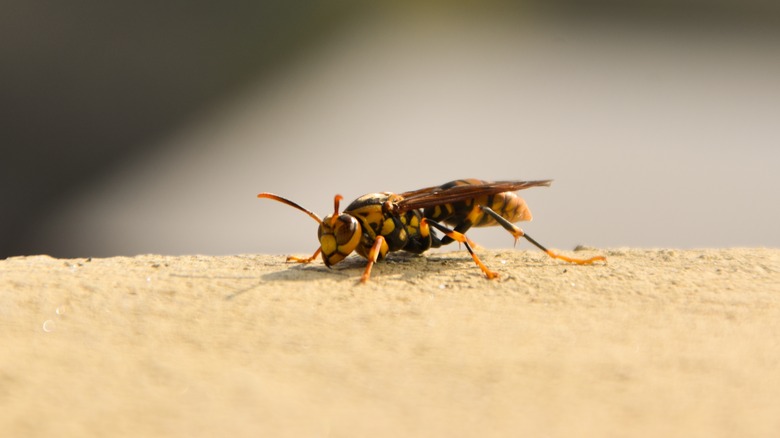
{"left": 0, "top": 249, "right": 780, "bottom": 437}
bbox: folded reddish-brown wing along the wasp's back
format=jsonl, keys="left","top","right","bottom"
{"left": 397, "top": 179, "right": 552, "bottom": 213}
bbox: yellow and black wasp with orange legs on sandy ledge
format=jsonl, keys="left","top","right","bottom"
{"left": 257, "top": 179, "right": 606, "bottom": 283}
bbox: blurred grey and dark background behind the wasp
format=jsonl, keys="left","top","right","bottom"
{"left": 0, "top": 0, "right": 780, "bottom": 257}
